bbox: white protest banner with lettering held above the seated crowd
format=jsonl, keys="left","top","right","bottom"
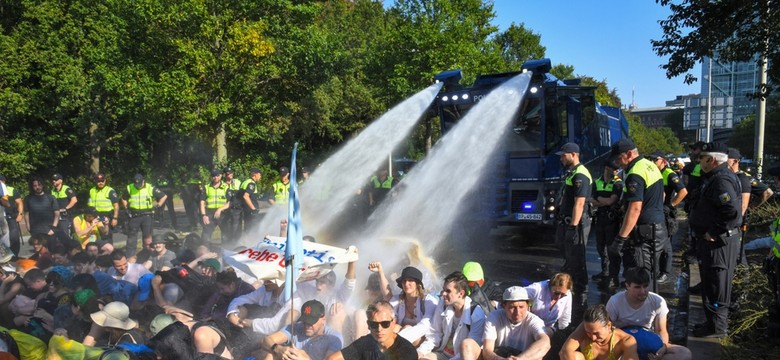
{"left": 223, "top": 236, "right": 358, "bottom": 282}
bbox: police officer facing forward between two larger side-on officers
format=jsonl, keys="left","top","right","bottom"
{"left": 590, "top": 162, "right": 623, "bottom": 288}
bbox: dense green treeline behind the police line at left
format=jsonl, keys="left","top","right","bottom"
{"left": 0, "top": 0, "right": 676, "bottom": 191}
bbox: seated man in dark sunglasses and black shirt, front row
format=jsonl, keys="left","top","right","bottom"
{"left": 326, "top": 300, "right": 418, "bottom": 360}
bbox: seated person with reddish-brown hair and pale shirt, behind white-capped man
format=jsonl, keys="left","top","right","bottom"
{"left": 525, "top": 273, "right": 572, "bottom": 336}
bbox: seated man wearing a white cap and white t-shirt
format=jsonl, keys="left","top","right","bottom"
{"left": 463, "top": 286, "right": 550, "bottom": 359}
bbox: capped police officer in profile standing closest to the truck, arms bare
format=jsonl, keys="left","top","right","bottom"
{"left": 555, "top": 143, "right": 592, "bottom": 324}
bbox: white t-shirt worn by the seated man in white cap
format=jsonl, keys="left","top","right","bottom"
{"left": 484, "top": 309, "right": 544, "bottom": 351}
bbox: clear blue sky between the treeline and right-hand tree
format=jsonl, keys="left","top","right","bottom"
{"left": 493, "top": 0, "right": 701, "bottom": 108}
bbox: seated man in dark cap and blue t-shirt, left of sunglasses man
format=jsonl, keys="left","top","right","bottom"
{"left": 262, "top": 300, "right": 344, "bottom": 360}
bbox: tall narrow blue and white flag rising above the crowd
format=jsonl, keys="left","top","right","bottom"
{"left": 284, "top": 143, "right": 303, "bottom": 301}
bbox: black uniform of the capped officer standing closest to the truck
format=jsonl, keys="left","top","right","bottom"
{"left": 556, "top": 164, "right": 591, "bottom": 324}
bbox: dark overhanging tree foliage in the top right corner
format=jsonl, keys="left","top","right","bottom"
{"left": 651, "top": 0, "right": 780, "bottom": 95}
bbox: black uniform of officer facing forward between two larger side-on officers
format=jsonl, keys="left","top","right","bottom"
{"left": 593, "top": 175, "right": 623, "bottom": 285}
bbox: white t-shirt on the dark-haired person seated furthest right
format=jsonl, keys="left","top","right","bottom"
{"left": 607, "top": 290, "right": 669, "bottom": 332}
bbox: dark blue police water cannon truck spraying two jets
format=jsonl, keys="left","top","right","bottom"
{"left": 432, "top": 59, "right": 628, "bottom": 231}
